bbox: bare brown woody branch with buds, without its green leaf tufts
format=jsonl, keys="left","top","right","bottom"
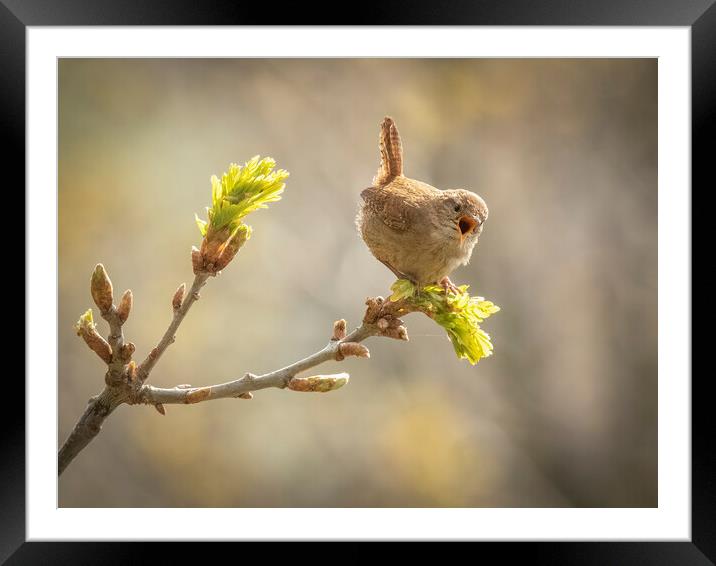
{"left": 58, "top": 265, "right": 411, "bottom": 474}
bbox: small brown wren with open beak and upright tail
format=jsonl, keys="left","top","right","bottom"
{"left": 356, "top": 116, "right": 487, "bottom": 290}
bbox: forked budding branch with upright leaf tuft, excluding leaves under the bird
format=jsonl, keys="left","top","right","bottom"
{"left": 58, "top": 156, "right": 420, "bottom": 474}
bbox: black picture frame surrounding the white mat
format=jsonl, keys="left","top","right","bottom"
{"left": 0, "top": 0, "right": 704, "bottom": 565}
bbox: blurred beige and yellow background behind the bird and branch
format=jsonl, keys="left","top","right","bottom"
{"left": 58, "top": 59, "right": 657, "bottom": 507}
